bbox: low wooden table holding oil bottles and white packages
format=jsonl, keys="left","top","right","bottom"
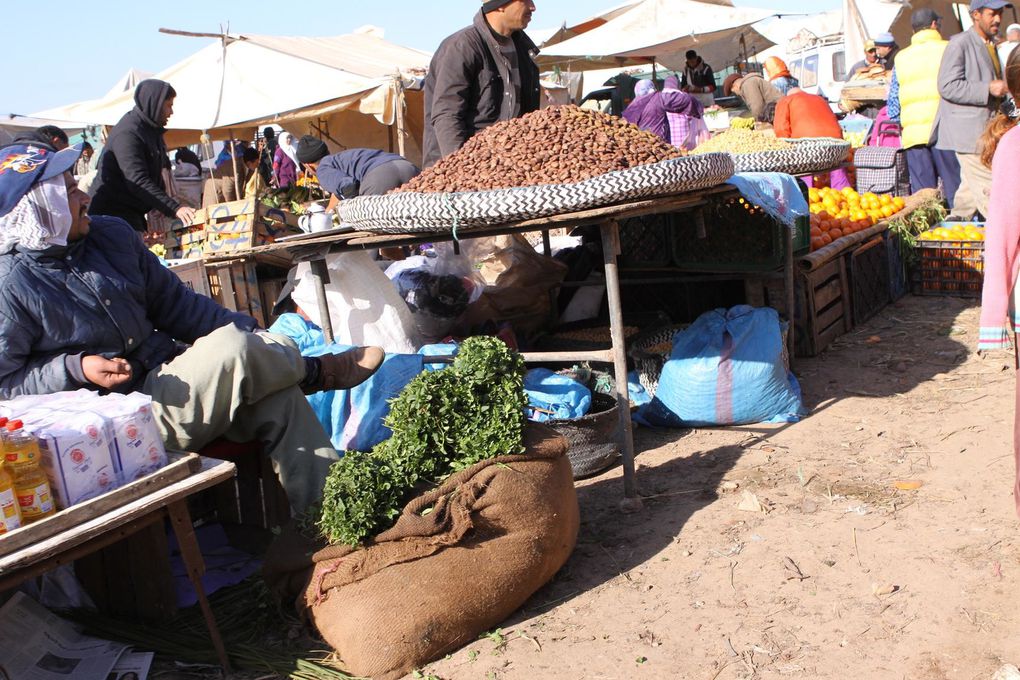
{"left": 0, "top": 458, "right": 236, "bottom": 672}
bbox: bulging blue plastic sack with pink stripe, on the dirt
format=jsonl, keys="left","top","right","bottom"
{"left": 636, "top": 305, "right": 803, "bottom": 427}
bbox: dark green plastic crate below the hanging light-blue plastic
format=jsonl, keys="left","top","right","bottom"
{"left": 672, "top": 197, "right": 811, "bottom": 272}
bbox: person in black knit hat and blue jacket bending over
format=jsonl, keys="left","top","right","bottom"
{"left": 298, "top": 135, "right": 420, "bottom": 208}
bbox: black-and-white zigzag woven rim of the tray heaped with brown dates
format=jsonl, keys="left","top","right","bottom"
{"left": 339, "top": 153, "right": 733, "bottom": 233}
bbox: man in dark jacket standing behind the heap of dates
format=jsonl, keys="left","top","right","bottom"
{"left": 423, "top": 0, "right": 541, "bottom": 167}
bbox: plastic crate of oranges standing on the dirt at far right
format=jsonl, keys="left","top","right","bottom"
{"left": 917, "top": 241, "right": 984, "bottom": 298}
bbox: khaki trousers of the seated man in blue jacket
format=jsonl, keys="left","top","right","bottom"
{"left": 143, "top": 325, "right": 340, "bottom": 513}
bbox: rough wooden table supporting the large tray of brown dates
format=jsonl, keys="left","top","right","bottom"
{"left": 206, "top": 185, "right": 794, "bottom": 512}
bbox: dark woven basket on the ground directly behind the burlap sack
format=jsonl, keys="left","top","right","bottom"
{"left": 545, "top": 393, "right": 620, "bottom": 479}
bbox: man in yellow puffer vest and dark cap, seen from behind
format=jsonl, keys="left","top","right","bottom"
{"left": 888, "top": 7, "right": 960, "bottom": 207}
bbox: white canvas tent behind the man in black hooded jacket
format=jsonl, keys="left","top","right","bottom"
{"left": 40, "top": 34, "right": 429, "bottom": 161}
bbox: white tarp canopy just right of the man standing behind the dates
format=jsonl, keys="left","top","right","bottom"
{"left": 539, "top": 0, "right": 775, "bottom": 70}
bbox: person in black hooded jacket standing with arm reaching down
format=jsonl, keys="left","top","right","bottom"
{"left": 89, "top": 79, "right": 195, "bottom": 231}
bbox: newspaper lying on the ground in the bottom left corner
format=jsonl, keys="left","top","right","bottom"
{"left": 0, "top": 592, "right": 130, "bottom": 680}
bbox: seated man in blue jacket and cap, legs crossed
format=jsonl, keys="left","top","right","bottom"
{"left": 0, "top": 144, "right": 384, "bottom": 512}
